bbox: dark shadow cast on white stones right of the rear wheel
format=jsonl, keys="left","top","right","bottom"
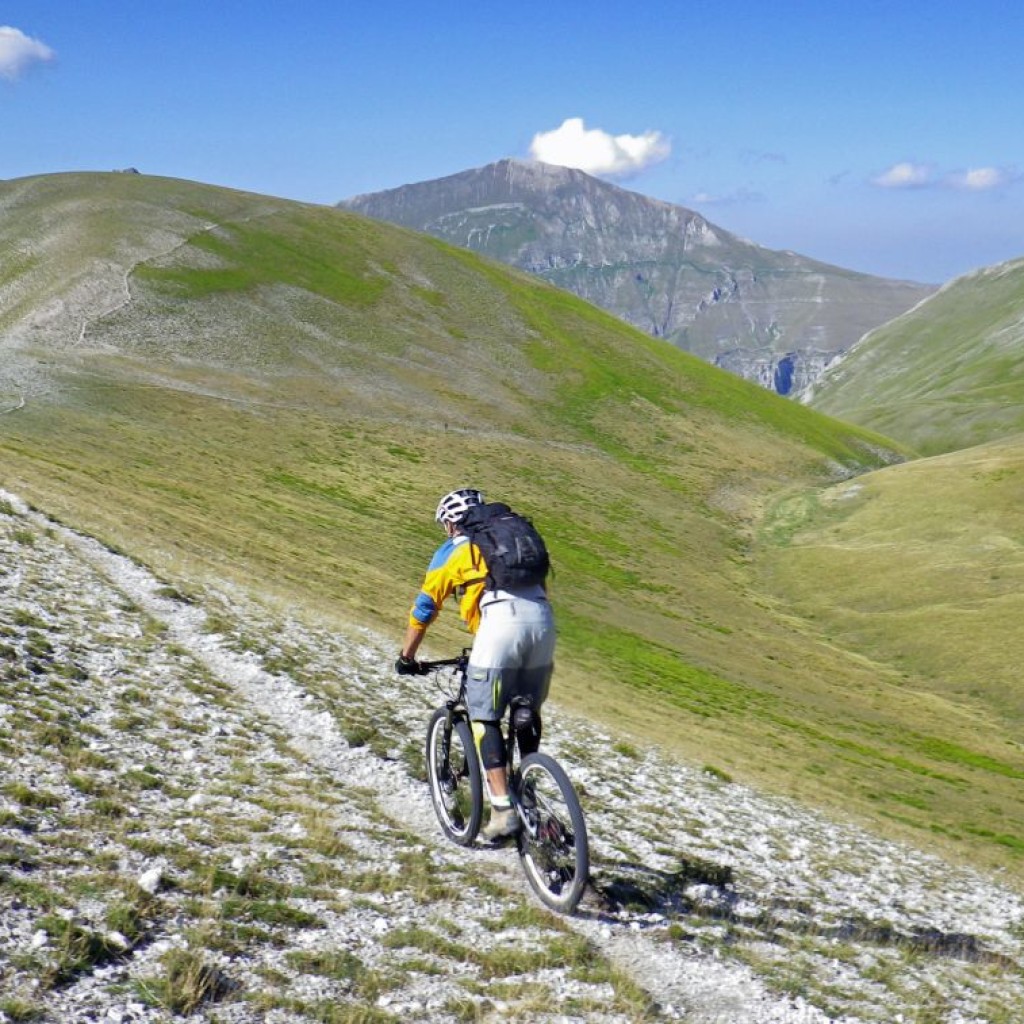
{"left": 577, "top": 857, "right": 1018, "bottom": 970}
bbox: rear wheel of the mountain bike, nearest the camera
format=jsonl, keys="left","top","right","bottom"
{"left": 516, "top": 752, "right": 590, "bottom": 913}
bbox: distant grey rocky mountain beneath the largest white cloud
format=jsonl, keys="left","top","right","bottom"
{"left": 338, "top": 160, "right": 935, "bottom": 394}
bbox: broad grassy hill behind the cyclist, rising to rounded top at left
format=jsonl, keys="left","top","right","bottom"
{"left": 0, "top": 176, "right": 1024, "bottom": 876}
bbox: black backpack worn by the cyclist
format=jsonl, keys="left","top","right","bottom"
{"left": 459, "top": 502, "right": 551, "bottom": 590}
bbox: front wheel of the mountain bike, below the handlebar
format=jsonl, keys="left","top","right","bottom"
{"left": 427, "top": 708, "right": 483, "bottom": 846}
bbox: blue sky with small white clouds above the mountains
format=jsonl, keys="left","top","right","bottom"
{"left": 0, "top": 0, "right": 1024, "bottom": 283}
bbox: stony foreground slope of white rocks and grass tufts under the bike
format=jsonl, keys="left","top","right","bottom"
{"left": 0, "top": 493, "right": 1024, "bottom": 1024}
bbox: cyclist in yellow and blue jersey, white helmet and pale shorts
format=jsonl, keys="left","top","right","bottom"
{"left": 395, "top": 487, "right": 555, "bottom": 840}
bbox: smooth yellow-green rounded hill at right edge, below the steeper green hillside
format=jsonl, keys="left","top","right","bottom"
{"left": 760, "top": 438, "right": 1024, "bottom": 708}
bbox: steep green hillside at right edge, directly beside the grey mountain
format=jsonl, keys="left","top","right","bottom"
{"left": 810, "top": 260, "right": 1024, "bottom": 455}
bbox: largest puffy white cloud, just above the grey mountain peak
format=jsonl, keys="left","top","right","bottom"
{"left": 529, "top": 118, "right": 672, "bottom": 177}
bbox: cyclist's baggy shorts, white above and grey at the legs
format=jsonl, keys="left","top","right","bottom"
{"left": 466, "top": 596, "right": 555, "bottom": 722}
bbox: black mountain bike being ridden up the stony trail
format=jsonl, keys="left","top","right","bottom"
{"left": 420, "top": 649, "right": 590, "bottom": 913}
